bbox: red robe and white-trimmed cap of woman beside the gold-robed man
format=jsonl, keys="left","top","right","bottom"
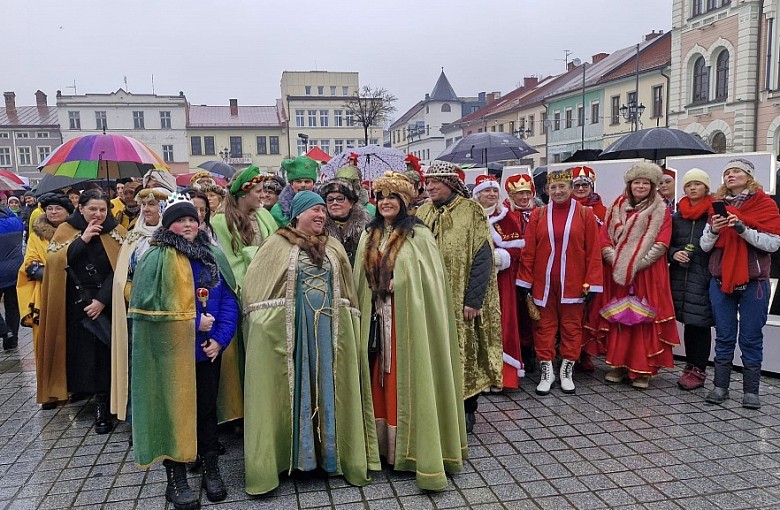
{"left": 472, "top": 175, "right": 525, "bottom": 388}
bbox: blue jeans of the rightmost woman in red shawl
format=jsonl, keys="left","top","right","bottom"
{"left": 710, "top": 278, "right": 769, "bottom": 368}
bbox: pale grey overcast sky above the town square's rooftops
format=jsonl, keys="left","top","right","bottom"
{"left": 0, "top": 0, "right": 672, "bottom": 120}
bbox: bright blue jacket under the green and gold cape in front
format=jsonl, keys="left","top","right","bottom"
{"left": 190, "top": 259, "right": 239, "bottom": 362}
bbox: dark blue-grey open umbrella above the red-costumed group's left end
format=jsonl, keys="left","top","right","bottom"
{"left": 436, "top": 132, "right": 538, "bottom": 166}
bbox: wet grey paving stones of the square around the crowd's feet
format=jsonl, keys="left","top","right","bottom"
{"left": 0, "top": 326, "right": 780, "bottom": 510}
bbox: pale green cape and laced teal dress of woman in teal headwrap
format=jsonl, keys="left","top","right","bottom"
{"left": 242, "top": 229, "right": 380, "bottom": 494}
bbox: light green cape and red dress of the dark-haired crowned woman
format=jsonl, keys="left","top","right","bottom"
{"left": 355, "top": 226, "right": 468, "bottom": 490}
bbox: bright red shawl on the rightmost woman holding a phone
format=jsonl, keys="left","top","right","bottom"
{"left": 715, "top": 189, "right": 780, "bottom": 294}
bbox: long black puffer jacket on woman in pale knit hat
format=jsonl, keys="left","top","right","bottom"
{"left": 668, "top": 212, "right": 715, "bottom": 328}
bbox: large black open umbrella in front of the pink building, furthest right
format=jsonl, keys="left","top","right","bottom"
{"left": 599, "top": 128, "right": 715, "bottom": 161}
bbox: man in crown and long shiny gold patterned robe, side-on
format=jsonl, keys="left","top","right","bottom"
{"left": 417, "top": 160, "right": 503, "bottom": 432}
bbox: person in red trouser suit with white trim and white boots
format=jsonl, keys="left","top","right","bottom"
{"left": 517, "top": 170, "right": 603, "bottom": 395}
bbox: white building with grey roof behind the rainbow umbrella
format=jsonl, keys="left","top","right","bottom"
{"left": 57, "top": 88, "right": 189, "bottom": 173}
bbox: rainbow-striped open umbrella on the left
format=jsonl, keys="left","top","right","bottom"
{"left": 38, "top": 135, "right": 168, "bottom": 179}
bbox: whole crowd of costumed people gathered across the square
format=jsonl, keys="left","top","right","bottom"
{"left": 0, "top": 156, "right": 780, "bottom": 509}
